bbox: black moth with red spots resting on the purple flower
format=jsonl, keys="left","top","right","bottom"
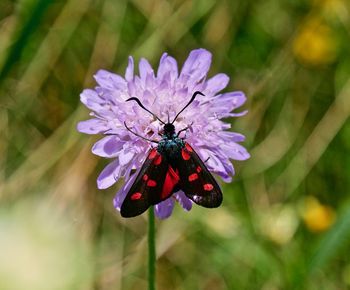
{"left": 120, "top": 91, "right": 222, "bottom": 217}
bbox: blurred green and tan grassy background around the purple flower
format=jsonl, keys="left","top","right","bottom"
{"left": 0, "top": 0, "right": 350, "bottom": 290}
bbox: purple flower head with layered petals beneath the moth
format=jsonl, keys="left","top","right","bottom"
{"left": 77, "top": 49, "right": 249, "bottom": 218}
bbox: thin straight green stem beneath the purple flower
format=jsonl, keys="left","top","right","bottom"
{"left": 148, "top": 206, "right": 156, "bottom": 290}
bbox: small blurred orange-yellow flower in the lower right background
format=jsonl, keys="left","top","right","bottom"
{"left": 302, "top": 196, "right": 335, "bottom": 232}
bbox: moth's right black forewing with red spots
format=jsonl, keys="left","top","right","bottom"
{"left": 174, "top": 143, "right": 222, "bottom": 208}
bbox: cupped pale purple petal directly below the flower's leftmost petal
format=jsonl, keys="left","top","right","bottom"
{"left": 92, "top": 136, "right": 125, "bottom": 159}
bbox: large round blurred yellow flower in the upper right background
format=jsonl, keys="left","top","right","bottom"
{"left": 293, "top": 18, "right": 336, "bottom": 66}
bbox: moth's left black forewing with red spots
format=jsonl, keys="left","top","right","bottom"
{"left": 120, "top": 148, "right": 178, "bottom": 217}
